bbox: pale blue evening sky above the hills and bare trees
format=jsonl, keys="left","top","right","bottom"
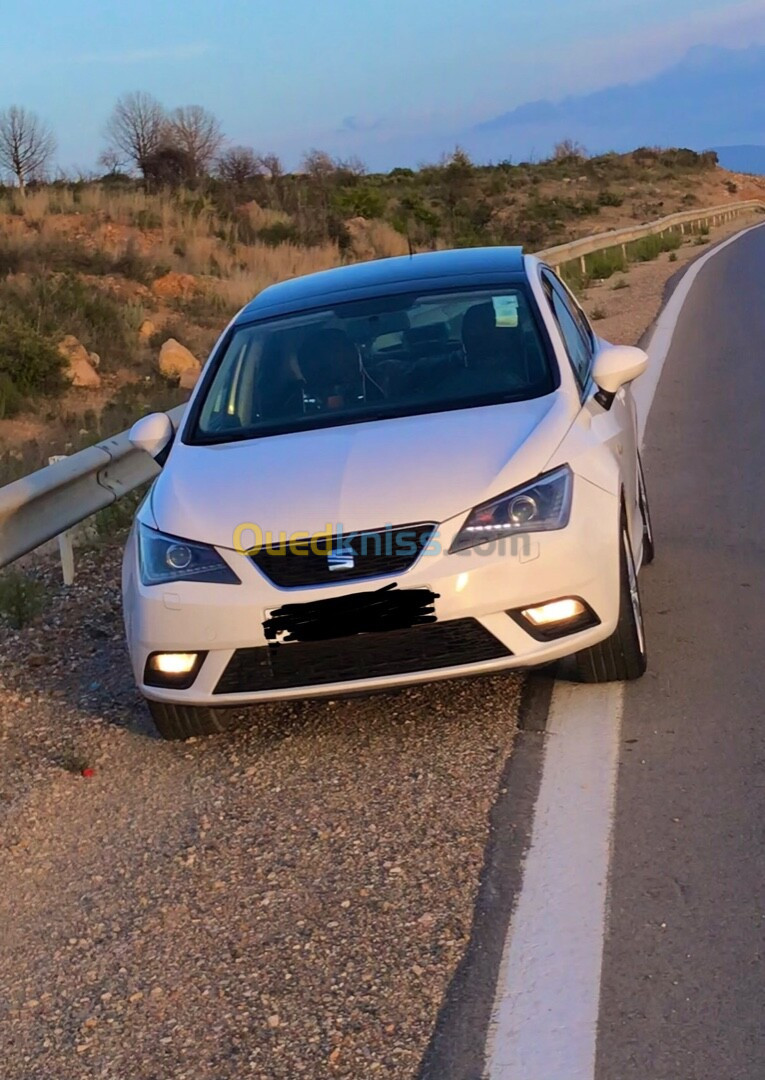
{"left": 0, "top": 0, "right": 765, "bottom": 170}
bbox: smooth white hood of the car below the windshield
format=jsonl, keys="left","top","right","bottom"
{"left": 151, "top": 391, "right": 573, "bottom": 548}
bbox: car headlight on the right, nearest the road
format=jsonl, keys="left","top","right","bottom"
{"left": 449, "top": 465, "right": 574, "bottom": 552}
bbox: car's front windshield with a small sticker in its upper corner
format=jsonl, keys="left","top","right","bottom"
{"left": 192, "top": 287, "right": 554, "bottom": 442}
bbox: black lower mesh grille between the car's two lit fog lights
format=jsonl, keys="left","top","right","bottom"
{"left": 215, "top": 619, "right": 512, "bottom": 693}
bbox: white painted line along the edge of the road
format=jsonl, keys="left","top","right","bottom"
{"left": 485, "top": 217, "right": 762, "bottom": 1080}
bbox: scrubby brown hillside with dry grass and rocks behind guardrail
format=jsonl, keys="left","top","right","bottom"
{"left": 0, "top": 149, "right": 765, "bottom": 481}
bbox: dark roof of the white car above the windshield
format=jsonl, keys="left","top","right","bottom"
{"left": 234, "top": 247, "right": 525, "bottom": 324}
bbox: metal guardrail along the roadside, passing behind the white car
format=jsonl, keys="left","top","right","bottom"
{"left": 0, "top": 200, "right": 765, "bottom": 567}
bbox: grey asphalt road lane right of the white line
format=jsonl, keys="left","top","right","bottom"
{"left": 596, "top": 223, "right": 765, "bottom": 1080}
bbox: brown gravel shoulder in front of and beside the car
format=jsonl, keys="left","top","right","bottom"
{"left": 0, "top": 543, "right": 521, "bottom": 1080}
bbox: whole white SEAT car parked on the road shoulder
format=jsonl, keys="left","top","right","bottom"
{"left": 123, "top": 247, "right": 653, "bottom": 739}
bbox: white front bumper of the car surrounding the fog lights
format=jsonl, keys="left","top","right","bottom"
{"left": 123, "top": 476, "right": 619, "bottom": 706}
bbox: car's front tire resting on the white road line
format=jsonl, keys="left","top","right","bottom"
{"left": 574, "top": 514, "right": 646, "bottom": 683}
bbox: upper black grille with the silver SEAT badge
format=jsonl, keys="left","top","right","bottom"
{"left": 250, "top": 523, "right": 435, "bottom": 589}
